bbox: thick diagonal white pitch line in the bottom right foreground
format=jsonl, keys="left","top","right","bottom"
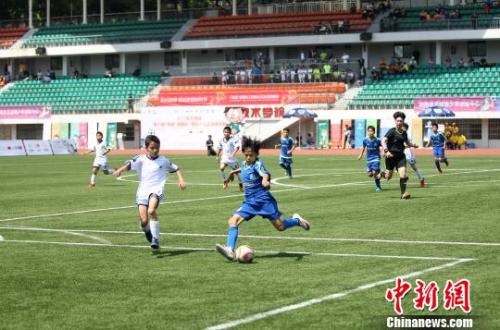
{"left": 206, "top": 259, "right": 471, "bottom": 330}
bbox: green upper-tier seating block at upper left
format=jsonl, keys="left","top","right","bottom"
{"left": 23, "top": 18, "right": 187, "bottom": 48}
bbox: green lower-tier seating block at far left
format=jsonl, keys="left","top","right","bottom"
{"left": 0, "top": 74, "right": 159, "bottom": 113}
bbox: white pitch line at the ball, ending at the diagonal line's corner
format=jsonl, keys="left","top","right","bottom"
{"left": 2, "top": 239, "right": 475, "bottom": 261}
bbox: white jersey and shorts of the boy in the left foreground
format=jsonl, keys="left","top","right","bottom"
{"left": 128, "top": 155, "right": 179, "bottom": 204}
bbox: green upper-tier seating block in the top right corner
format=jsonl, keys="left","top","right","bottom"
{"left": 380, "top": 3, "right": 500, "bottom": 32}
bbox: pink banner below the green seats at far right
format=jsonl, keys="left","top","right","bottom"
{"left": 414, "top": 96, "right": 499, "bottom": 112}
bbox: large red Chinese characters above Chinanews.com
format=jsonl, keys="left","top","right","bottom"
{"left": 385, "top": 277, "right": 472, "bottom": 315}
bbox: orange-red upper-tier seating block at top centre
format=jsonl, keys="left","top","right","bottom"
{"left": 185, "top": 10, "right": 370, "bottom": 39}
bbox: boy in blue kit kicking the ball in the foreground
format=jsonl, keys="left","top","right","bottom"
{"left": 216, "top": 136, "right": 311, "bottom": 261}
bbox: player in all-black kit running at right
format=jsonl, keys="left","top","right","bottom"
{"left": 380, "top": 111, "right": 418, "bottom": 199}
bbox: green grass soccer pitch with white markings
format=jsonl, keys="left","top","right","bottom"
{"left": 0, "top": 155, "right": 500, "bottom": 329}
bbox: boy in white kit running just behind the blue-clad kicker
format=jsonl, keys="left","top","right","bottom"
{"left": 216, "top": 126, "right": 243, "bottom": 192}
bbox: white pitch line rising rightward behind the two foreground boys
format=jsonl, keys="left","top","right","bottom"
{"left": 0, "top": 169, "right": 500, "bottom": 222}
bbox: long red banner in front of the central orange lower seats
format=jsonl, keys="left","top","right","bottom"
{"left": 156, "top": 90, "right": 299, "bottom": 106}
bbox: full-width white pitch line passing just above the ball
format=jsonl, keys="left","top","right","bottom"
{"left": 0, "top": 226, "right": 500, "bottom": 246}
